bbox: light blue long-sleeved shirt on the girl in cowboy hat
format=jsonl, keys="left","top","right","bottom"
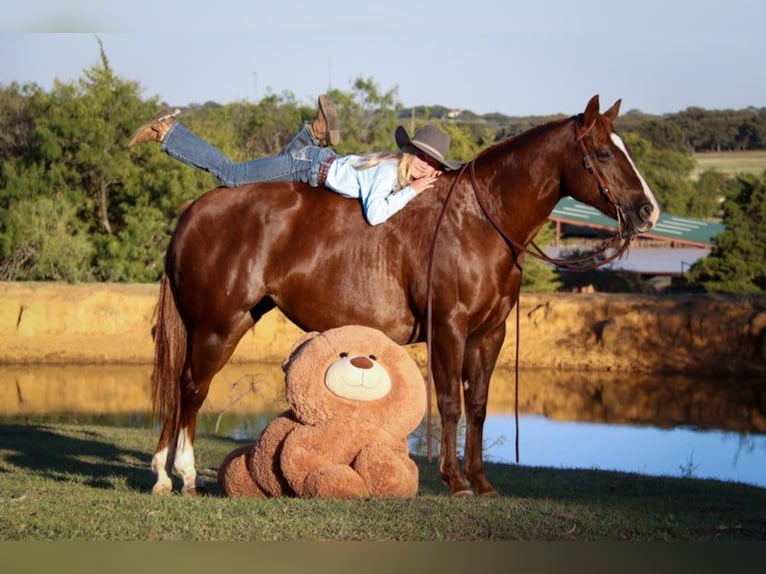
{"left": 325, "top": 155, "right": 417, "bottom": 225}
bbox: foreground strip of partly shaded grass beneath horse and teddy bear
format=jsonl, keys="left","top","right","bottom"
{"left": 0, "top": 424, "right": 766, "bottom": 541}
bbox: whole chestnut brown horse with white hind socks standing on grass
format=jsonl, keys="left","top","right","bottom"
{"left": 152, "top": 95, "right": 660, "bottom": 496}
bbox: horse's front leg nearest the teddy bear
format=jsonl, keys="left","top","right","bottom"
{"left": 431, "top": 329, "right": 473, "bottom": 495}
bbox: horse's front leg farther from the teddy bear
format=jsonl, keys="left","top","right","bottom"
{"left": 463, "top": 323, "right": 505, "bottom": 496}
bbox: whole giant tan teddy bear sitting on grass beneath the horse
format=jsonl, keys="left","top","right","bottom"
{"left": 218, "top": 325, "right": 426, "bottom": 498}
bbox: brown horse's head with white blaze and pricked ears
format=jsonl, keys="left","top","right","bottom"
{"left": 565, "top": 95, "right": 660, "bottom": 235}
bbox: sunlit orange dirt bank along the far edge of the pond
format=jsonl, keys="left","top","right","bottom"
{"left": 0, "top": 283, "right": 766, "bottom": 376}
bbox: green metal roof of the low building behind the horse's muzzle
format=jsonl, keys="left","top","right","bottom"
{"left": 549, "top": 197, "right": 726, "bottom": 247}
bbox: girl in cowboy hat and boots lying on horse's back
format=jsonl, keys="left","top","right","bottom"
{"left": 128, "top": 95, "right": 460, "bottom": 225}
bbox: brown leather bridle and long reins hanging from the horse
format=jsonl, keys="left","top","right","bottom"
{"left": 426, "top": 114, "right": 631, "bottom": 464}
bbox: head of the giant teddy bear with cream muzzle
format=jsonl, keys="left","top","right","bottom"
{"left": 283, "top": 325, "right": 426, "bottom": 435}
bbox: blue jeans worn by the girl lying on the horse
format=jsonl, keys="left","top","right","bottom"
{"left": 160, "top": 122, "right": 337, "bottom": 187}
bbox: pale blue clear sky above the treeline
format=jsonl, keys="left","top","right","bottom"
{"left": 0, "top": 0, "right": 766, "bottom": 116}
